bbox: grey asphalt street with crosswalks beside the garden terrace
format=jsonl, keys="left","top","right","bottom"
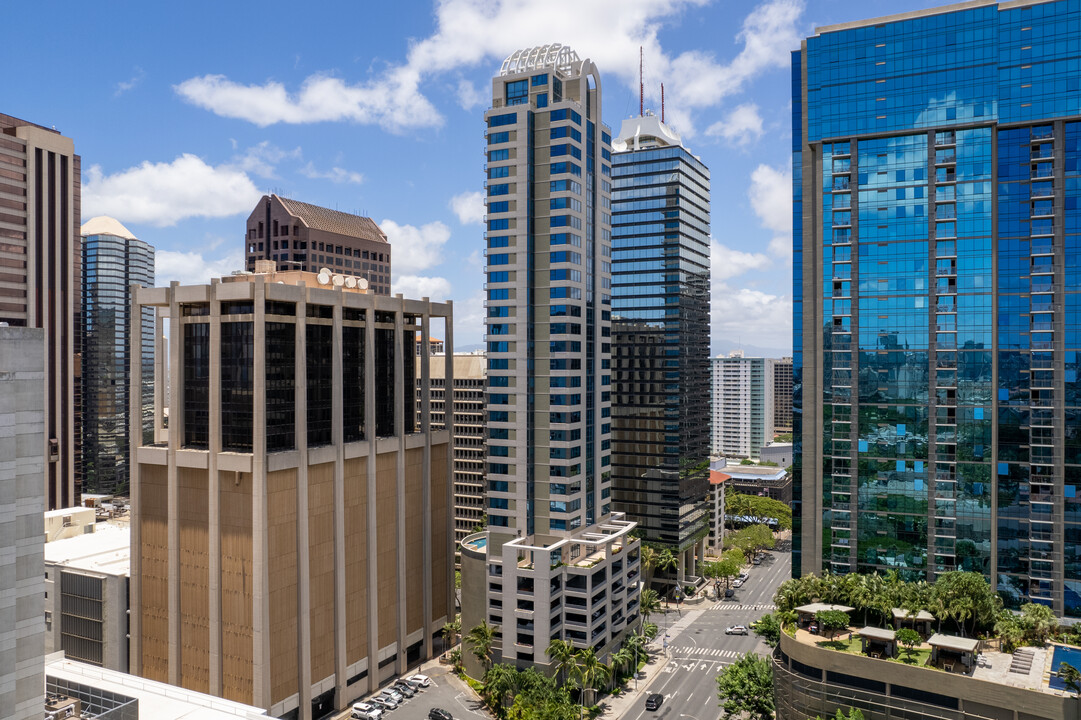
{"left": 624, "top": 552, "right": 791, "bottom": 720}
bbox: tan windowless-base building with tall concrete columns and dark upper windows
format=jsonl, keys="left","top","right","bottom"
{"left": 131, "top": 264, "right": 454, "bottom": 718}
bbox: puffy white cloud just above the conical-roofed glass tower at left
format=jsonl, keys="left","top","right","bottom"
{"left": 82, "top": 154, "right": 262, "bottom": 227}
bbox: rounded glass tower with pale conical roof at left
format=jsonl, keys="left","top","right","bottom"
{"left": 81, "top": 216, "right": 155, "bottom": 494}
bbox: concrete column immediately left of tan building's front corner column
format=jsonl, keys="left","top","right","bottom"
{"left": 206, "top": 278, "right": 222, "bottom": 696}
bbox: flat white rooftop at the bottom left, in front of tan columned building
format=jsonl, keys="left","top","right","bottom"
{"left": 45, "top": 653, "right": 267, "bottom": 720}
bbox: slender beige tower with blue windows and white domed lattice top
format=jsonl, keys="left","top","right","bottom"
{"left": 462, "top": 44, "right": 639, "bottom": 665}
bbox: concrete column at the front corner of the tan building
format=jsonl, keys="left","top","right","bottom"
{"left": 252, "top": 277, "right": 270, "bottom": 710}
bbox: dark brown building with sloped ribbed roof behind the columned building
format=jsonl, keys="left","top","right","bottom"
{"left": 245, "top": 195, "right": 390, "bottom": 295}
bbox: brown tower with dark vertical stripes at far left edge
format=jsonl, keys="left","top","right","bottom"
{"left": 0, "top": 115, "right": 82, "bottom": 503}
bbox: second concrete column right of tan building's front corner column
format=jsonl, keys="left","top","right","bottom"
{"left": 331, "top": 293, "right": 348, "bottom": 710}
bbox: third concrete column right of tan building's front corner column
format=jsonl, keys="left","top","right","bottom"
{"left": 364, "top": 295, "right": 379, "bottom": 692}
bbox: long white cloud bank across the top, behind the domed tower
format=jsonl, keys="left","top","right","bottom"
{"left": 175, "top": 0, "right": 803, "bottom": 136}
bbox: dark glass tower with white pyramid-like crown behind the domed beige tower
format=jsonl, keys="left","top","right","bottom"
{"left": 612, "top": 114, "right": 710, "bottom": 576}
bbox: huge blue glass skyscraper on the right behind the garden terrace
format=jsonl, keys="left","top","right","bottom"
{"left": 792, "top": 0, "right": 1081, "bottom": 616}
